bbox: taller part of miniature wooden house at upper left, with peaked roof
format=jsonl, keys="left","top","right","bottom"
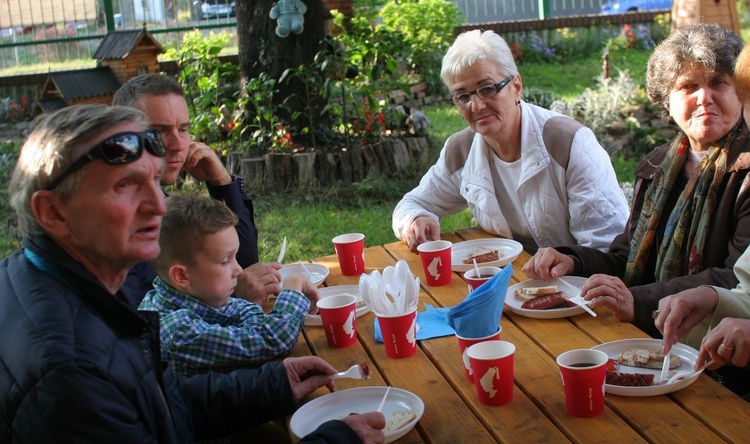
{"left": 94, "top": 28, "right": 164, "bottom": 84}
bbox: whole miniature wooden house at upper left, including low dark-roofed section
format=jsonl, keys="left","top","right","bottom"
{"left": 34, "top": 28, "right": 164, "bottom": 114}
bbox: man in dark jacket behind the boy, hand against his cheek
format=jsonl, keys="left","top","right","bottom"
{"left": 114, "top": 74, "right": 281, "bottom": 307}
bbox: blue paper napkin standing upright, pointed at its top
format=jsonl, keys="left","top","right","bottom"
{"left": 447, "top": 264, "right": 513, "bottom": 338}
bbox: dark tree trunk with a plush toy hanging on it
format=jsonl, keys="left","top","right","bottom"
{"left": 236, "top": 0, "right": 330, "bottom": 147}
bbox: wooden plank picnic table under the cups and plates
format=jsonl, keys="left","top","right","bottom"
{"left": 284, "top": 228, "right": 750, "bottom": 443}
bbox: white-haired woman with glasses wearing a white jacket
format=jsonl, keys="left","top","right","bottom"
{"left": 393, "top": 30, "right": 628, "bottom": 252}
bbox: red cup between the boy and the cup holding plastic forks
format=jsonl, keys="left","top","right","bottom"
{"left": 317, "top": 294, "right": 357, "bottom": 348}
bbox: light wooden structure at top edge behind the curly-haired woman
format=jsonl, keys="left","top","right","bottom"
{"left": 672, "top": 0, "right": 740, "bottom": 35}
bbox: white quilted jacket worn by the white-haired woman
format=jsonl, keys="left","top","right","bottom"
{"left": 392, "top": 102, "right": 629, "bottom": 251}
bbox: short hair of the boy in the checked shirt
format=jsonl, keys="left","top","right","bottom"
{"left": 150, "top": 192, "right": 239, "bottom": 278}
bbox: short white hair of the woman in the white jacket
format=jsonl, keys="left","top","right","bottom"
{"left": 440, "top": 29, "right": 518, "bottom": 89}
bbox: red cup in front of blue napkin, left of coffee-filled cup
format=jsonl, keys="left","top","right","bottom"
{"left": 466, "top": 341, "right": 516, "bottom": 406}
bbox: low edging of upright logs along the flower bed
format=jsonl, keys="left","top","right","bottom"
{"left": 225, "top": 137, "right": 430, "bottom": 192}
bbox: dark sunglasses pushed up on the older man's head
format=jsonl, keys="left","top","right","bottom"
{"left": 45, "top": 129, "right": 167, "bottom": 191}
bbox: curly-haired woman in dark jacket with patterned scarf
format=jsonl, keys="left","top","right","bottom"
{"left": 523, "top": 24, "right": 750, "bottom": 337}
